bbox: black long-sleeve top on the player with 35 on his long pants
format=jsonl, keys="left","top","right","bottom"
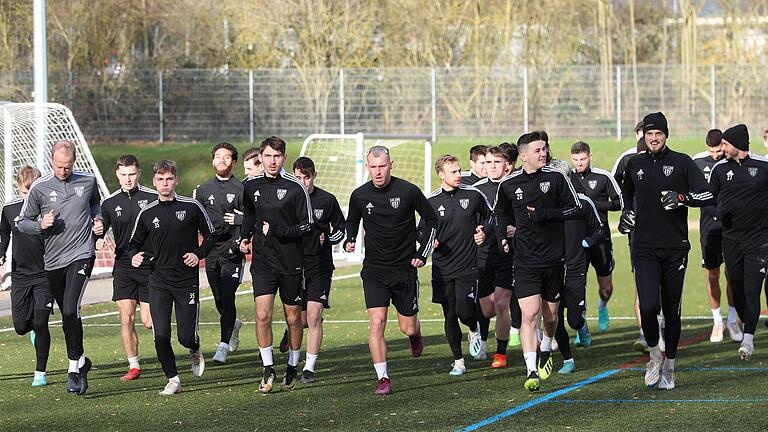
{"left": 129, "top": 195, "right": 216, "bottom": 290}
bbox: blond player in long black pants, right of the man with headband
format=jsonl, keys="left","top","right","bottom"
{"left": 428, "top": 155, "right": 493, "bottom": 376}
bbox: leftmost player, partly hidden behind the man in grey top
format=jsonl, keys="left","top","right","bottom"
{"left": 0, "top": 165, "right": 54, "bottom": 387}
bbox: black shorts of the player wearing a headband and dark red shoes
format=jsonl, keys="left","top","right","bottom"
{"left": 360, "top": 267, "right": 419, "bottom": 316}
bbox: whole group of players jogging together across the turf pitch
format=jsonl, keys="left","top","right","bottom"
{"left": 7, "top": 113, "right": 768, "bottom": 395}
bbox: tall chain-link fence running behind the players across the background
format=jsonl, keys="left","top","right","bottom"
{"left": 0, "top": 65, "right": 768, "bottom": 142}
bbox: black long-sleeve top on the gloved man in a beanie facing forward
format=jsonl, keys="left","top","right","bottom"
{"left": 624, "top": 147, "right": 715, "bottom": 249}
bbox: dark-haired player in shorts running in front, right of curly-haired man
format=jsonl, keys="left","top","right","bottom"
{"left": 240, "top": 136, "right": 314, "bottom": 393}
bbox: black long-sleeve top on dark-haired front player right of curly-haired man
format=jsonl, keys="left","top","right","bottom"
{"left": 240, "top": 170, "right": 313, "bottom": 274}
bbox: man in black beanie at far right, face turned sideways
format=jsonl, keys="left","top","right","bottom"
{"left": 709, "top": 124, "right": 768, "bottom": 360}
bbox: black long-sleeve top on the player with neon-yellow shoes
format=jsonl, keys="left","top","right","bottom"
{"left": 496, "top": 166, "right": 580, "bottom": 268}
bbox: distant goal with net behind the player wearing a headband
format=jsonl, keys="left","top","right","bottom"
{"left": 300, "top": 133, "right": 432, "bottom": 261}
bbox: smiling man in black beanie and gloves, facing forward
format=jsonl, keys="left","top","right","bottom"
{"left": 620, "top": 113, "right": 714, "bottom": 390}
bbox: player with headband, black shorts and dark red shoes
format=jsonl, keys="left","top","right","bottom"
{"left": 344, "top": 146, "right": 437, "bottom": 396}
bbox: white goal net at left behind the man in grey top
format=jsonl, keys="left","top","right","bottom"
{"left": 0, "top": 103, "right": 115, "bottom": 273}
